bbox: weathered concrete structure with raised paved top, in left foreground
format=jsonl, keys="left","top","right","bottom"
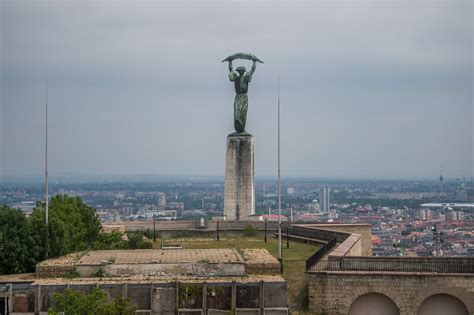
{"left": 0, "top": 249, "right": 288, "bottom": 315}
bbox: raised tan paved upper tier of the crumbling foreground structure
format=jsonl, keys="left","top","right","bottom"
{"left": 36, "top": 248, "right": 280, "bottom": 278}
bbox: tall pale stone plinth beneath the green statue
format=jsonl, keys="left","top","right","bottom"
{"left": 224, "top": 133, "right": 255, "bottom": 220}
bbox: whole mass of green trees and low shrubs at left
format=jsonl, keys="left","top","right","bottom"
{"left": 0, "top": 195, "right": 156, "bottom": 274}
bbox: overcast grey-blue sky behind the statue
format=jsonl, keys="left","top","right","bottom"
{"left": 0, "top": 0, "right": 474, "bottom": 178}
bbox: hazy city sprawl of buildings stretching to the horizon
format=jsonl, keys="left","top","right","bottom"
{"left": 0, "top": 177, "right": 474, "bottom": 256}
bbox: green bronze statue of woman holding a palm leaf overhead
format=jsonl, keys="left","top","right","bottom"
{"left": 222, "top": 53, "right": 263, "bottom": 133}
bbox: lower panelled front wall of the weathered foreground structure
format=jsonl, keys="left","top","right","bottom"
{"left": 0, "top": 276, "right": 288, "bottom": 315}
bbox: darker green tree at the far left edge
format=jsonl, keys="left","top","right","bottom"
{"left": 0, "top": 206, "right": 37, "bottom": 274}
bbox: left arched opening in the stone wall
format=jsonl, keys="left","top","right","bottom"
{"left": 349, "top": 293, "right": 400, "bottom": 315}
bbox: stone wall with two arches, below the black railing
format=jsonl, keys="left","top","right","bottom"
{"left": 308, "top": 272, "right": 474, "bottom": 315}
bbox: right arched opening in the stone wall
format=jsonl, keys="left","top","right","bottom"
{"left": 418, "top": 294, "right": 469, "bottom": 315}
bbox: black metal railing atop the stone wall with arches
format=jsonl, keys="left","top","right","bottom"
{"left": 306, "top": 257, "right": 474, "bottom": 273}
